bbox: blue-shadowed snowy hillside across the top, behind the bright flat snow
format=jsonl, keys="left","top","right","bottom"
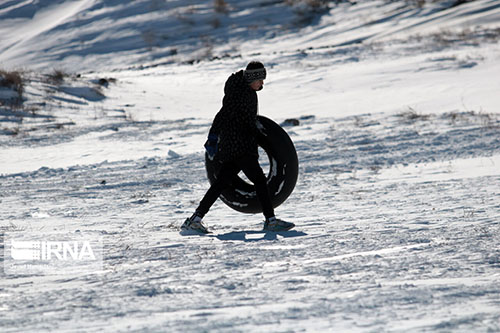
{"left": 0, "top": 0, "right": 500, "bottom": 72}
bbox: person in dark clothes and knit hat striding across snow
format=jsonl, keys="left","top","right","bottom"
{"left": 181, "top": 61, "right": 295, "bottom": 233}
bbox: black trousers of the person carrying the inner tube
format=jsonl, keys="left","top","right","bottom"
{"left": 196, "top": 155, "right": 274, "bottom": 218}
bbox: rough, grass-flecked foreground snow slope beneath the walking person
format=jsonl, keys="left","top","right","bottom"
{"left": 0, "top": 110, "right": 500, "bottom": 332}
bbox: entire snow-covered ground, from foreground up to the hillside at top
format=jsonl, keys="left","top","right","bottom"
{"left": 0, "top": 0, "right": 500, "bottom": 332}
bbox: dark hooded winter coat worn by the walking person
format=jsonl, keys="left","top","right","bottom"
{"left": 210, "top": 71, "right": 258, "bottom": 162}
